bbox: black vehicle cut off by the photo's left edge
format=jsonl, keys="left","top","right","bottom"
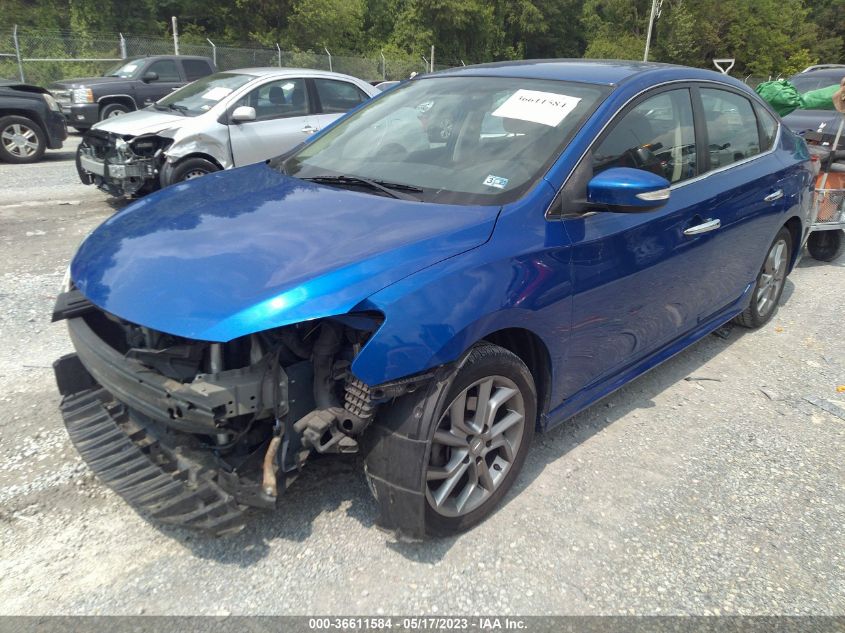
{"left": 0, "top": 80, "right": 67, "bottom": 163}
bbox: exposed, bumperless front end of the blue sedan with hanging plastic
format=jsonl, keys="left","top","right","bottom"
{"left": 53, "top": 288, "right": 430, "bottom": 534}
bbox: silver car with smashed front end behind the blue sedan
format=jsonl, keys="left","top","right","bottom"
{"left": 77, "top": 68, "right": 379, "bottom": 196}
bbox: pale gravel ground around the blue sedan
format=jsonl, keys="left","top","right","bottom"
{"left": 0, "top": 138, "right": 845, "bottom": 615}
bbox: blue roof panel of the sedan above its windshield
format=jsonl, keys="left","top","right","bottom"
{"left": 432, "top": 59, "right": 741, "bottom": 86}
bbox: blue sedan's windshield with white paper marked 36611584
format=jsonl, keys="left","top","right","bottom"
{"left": 280, "top": 77, "right": 610, "bottom": 204}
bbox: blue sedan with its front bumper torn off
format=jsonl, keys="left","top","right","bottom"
{"left": 54, "top": 61, "right": 813, "bottom": 537}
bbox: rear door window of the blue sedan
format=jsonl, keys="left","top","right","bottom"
{"left": 701, "top": 88, "right": 760, "bottom": 169}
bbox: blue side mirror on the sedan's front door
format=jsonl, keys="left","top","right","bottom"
{"left": 587, "top": 167, "right": 671, "bottom": 213}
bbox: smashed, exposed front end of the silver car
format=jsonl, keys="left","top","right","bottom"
{"left": 76, "top": 129, "right": 173, "bottom": 197}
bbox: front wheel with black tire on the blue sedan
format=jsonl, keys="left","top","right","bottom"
{"left": 367, "top": 343, "right": 537, "bottom": 536}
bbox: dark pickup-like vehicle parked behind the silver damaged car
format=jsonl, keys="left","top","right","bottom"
{"left": 49, "top": 55, "right": 217, "bottom": 132}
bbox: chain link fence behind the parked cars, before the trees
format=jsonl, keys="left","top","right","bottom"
{"left": 0, "top": 27, "right": 454, "bottom": 86}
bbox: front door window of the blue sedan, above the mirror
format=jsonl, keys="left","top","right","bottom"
{"left": 593, "top": 89, "right": 698, "bottom": 183}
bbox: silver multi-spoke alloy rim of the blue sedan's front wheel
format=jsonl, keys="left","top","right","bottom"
{"left": 426, "top": 376, "right": 526, "bottom": 517}
